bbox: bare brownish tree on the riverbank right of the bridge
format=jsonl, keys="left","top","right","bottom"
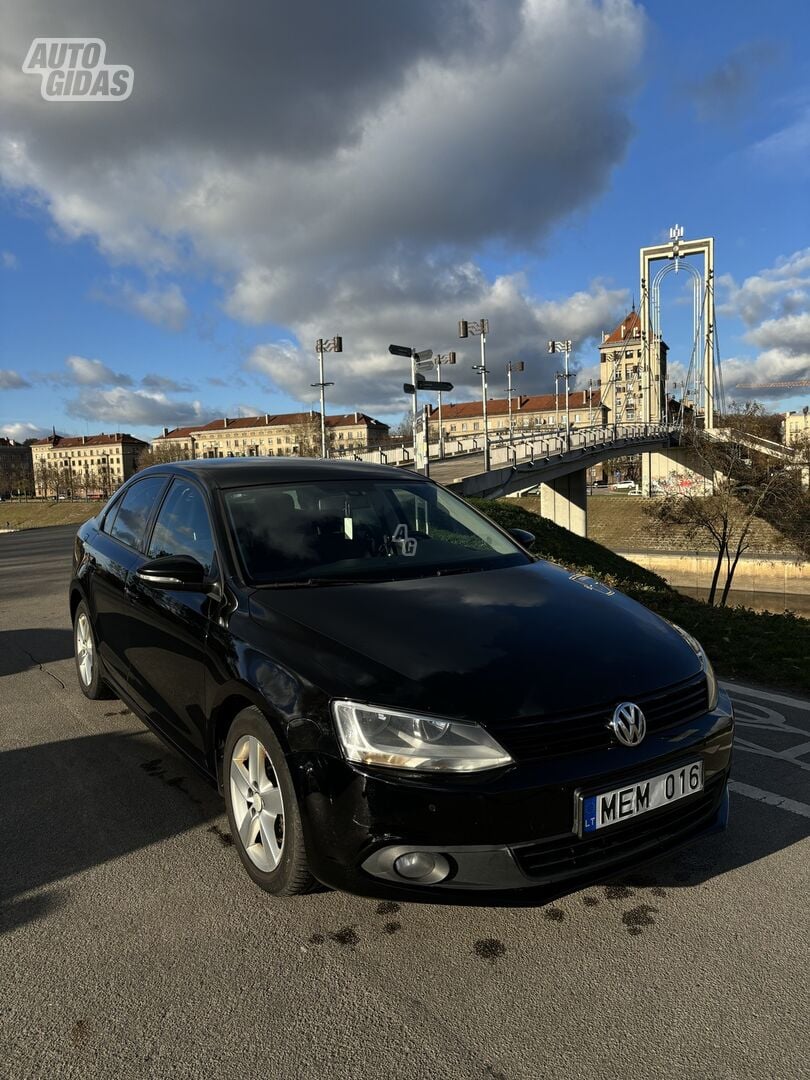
{"left": 645, "top": 431, "right": 805, "bottom": 607}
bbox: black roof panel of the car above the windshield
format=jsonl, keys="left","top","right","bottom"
{"left": 138, "top": 458, "right": 426, "bottom": 488}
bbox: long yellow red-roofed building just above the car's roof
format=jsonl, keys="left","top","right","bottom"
{"left": 152, "top": 409, "right": 389, "bottom": 459}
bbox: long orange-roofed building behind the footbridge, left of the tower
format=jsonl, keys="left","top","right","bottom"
{"left": 430, "top": 389, "right": 607, "bottom": 440}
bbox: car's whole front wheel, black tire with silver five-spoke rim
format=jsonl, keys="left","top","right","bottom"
{"left": 222, "top": 708, "right": 314, "bottom": 896}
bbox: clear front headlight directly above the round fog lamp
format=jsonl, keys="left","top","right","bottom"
{"left": 332, "top": 701, "right": 512, "bottom": 772}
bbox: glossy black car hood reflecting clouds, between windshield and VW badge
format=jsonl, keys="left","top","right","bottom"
{"left": 249, "top": 562, "right": 700, "bottom": 727}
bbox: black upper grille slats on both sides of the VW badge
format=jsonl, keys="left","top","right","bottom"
{"left": 492, "top": 672, "right": 708, "bottom": 761}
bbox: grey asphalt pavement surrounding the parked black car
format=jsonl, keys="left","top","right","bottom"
{"left": 0, "top": 528, "right": 810, "bottom": 1080}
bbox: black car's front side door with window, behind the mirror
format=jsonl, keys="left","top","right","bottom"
{"left": 126, "top": 476, "right": 219, "bottom": 762}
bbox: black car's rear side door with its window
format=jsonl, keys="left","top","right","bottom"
{"left": 90, "top": 476, "right": 167, "bottom": 687}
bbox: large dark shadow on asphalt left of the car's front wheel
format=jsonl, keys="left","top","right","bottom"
{"left": 0, "top": 731, "right": 222, "bottom": 932}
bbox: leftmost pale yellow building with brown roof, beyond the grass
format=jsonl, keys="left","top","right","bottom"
{"left": 30, "top": 432, "right": 149, "bottom": 498}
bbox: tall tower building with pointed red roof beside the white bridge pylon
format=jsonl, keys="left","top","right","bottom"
{"left": 599, "top": 308, "right": 669, "bottom": 423}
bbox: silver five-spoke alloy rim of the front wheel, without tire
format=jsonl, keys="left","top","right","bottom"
{"left": 230, "top": 735, "right": 284, "bottom": 873}
